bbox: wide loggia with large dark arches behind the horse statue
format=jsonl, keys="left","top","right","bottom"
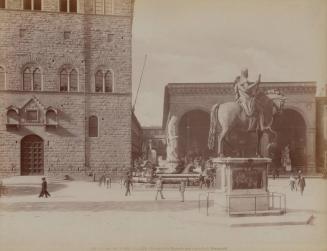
{"left": 162, "top": 82, "right": 316, "bottom": 172}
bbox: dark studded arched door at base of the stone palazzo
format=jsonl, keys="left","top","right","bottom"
{"left": 21, "top": 135, "right": 44, "bottom": 175}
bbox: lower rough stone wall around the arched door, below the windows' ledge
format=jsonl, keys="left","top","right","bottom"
{"left": 0, "top": 92, "right": 131, "bottom": 175}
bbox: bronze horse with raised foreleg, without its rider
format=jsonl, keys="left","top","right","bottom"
{"left": 208, "top": 90, "right": 285, "bottom": 157}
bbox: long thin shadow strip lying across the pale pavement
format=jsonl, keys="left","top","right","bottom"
{"left": 0, "top": 198, "right": 213, "bottom": 212}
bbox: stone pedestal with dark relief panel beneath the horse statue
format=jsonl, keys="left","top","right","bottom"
{"left": 212, "top": 158, "right": 271, "bottom": 214}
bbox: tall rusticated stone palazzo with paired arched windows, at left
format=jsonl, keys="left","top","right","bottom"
{"left": 0, "top": 0, "right": 133, "bottom": 176}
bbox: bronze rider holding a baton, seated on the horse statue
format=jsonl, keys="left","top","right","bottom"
{"left": 234, "top": 68, "right": 261, "bottom": 131}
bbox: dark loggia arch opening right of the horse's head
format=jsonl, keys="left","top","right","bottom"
{"left": 273, "top": 108, "right": 306, "bottom": 171}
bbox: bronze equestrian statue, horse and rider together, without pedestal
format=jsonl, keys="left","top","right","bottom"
{"left": 208, "top": 69, "right": 286, "bottom": 157}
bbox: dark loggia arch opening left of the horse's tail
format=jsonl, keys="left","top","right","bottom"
{"left": 178, "top": 110, "right": 210, "bottom": 158}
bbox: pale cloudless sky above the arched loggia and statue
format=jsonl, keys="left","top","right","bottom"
{"left": 133, "top": 0, "right": 327, "bottom": 126}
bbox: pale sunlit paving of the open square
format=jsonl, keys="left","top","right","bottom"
{"left": 0, "top": 177, "right": 327, "bottom": 251}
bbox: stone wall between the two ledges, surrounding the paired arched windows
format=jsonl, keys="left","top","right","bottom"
{"left": 0, "top": 10, "right": 132, "bottom": 92}
